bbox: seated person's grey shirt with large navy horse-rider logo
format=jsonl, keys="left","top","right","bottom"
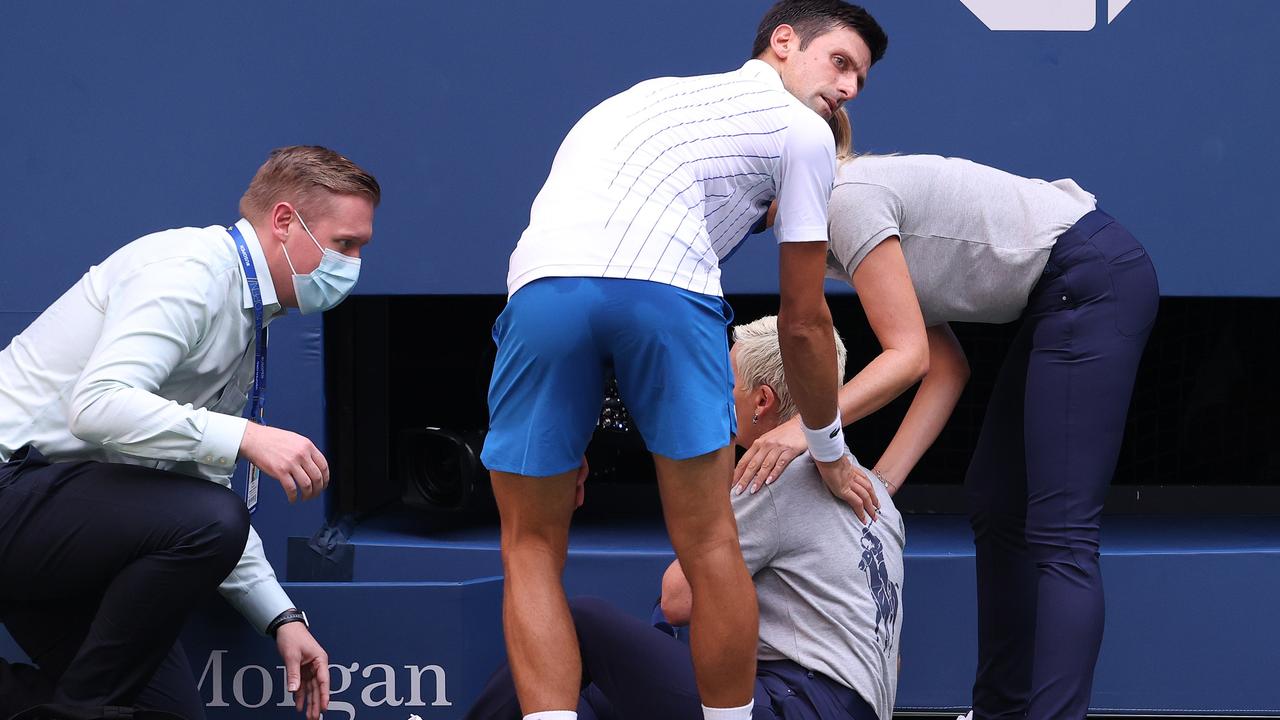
{"left": 732, "top": 452, "right": 906, "bottom": 720}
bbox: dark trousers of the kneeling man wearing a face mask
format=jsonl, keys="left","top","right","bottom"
{"left": 0, "top": 447, "right": 248, "bottom": 720}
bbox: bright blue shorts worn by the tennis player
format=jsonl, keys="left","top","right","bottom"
{"left": 480, "top": 278, "right": 737, "bottom": 477}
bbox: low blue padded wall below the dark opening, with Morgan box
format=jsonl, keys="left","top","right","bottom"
{"left": 0, "top": 516, "right": 1280, "bottom": 720}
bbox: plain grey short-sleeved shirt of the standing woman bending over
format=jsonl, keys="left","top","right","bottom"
{"left": 827, "top": 155, "right": 1097, "bottom": 325}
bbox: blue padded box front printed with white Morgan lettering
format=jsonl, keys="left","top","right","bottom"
{"left": 183, "top": 578, "right": 502, "bottom": 720}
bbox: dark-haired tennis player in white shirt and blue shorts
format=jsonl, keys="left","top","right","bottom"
{"left": 483, "top": 0, "right": 887, "bottom": 720}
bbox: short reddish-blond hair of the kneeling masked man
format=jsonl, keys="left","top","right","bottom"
{"left": 241, "top": 145, "right": 383, "bottom": 218}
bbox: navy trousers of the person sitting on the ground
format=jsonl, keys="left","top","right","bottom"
{"left": 466, "top": 598, "right": 887, "bottom": 720}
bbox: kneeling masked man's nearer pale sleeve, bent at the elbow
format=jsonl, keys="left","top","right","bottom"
{"left": 69, "top": 258, "right": 246, "bottom": 469}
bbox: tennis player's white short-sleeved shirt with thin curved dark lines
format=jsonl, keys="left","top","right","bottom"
{"left": 507, "top": 60, "right": 835, "bottom": 296}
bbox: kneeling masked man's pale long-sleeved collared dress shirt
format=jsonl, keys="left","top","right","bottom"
{"left": 0, "top": 219, "right": 293, "bottom": 632}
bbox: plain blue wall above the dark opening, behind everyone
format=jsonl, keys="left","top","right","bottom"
{"left": 0, "top": 0, "right": 1280, "bottom": 298}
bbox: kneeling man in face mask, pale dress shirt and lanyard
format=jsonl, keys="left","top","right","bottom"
{"left": 0, "top": 146, "right": 381, "bottom": 720}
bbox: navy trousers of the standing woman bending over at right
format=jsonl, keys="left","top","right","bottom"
{"left": 965, "top": 211, "right": 1160, "bottom": 720}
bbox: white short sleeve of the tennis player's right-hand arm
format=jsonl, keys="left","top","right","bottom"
{"left": 773, "top": 110, "right": 836, "bottom": 242}
